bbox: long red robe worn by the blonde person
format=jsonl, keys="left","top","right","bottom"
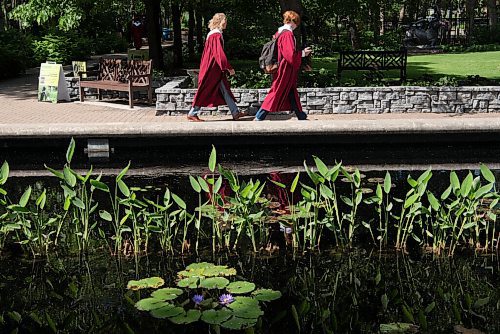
{"left": 193, "top": 33, "right": 234, "bottom": 107}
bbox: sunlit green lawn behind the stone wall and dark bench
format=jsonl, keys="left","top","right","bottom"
{"left": 231, "top": 51, "right": 500, "bottom": 80}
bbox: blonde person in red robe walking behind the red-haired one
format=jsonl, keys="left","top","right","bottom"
{"left": 187, "top": 13, "right": 246, "bottom": 122}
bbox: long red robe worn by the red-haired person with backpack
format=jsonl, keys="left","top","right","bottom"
{"left": 262, "top": 29, "right": 302, "bottom": 112}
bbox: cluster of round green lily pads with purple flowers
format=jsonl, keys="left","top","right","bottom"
{"left": 127, "top": 262, "right": 281, "bottom": 331}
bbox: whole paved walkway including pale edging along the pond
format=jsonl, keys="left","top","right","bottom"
{"left": 0, "top": 71, "right": 500, "bottom": 138}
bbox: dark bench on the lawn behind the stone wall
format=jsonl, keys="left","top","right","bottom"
{"left": 337, "top": 48, "right": 408, "bottom": 82}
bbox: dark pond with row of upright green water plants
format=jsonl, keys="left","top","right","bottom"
{"left": 0, "top": 142, "right": 500, "bottom": 333}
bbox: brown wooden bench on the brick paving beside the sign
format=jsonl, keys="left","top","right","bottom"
{"left": 79, "top": 58, "right": 153, "bottom": 108}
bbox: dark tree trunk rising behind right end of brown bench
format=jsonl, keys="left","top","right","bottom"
{"left": 144, "top": 0, "right": 163, "bottom": 70}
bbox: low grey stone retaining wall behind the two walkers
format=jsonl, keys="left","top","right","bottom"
{"left": 156, "top": 82, "right": 500, "bottom": 115}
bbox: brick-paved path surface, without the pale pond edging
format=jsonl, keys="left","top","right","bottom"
{"left": 0, "top": 70, "right": 500, "bottom": 126}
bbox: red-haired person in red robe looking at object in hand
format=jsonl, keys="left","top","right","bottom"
{"left": 254, "top": 10, "right": 312, "bottom": 121}
